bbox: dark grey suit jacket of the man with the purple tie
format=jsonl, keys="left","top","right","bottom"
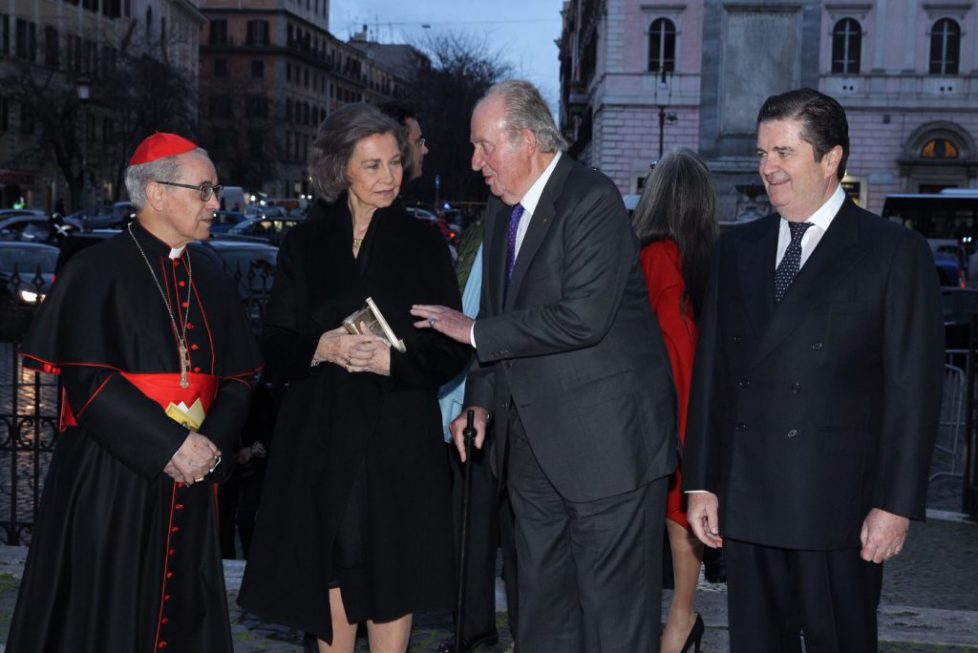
{"left": 466, "top": 155, "right": 676, "bottom": 502}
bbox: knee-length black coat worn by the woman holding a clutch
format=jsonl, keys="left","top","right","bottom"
{"left": 239, "top": 196, "right": 468, "bottom": 639}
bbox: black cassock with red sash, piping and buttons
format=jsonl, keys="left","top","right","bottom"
{"left": 6, "top": 224, "right": 260, "bottom": 653}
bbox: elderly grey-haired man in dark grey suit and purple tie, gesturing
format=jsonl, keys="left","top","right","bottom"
{"left": 412, "top": 81, "right": 676, "bottom": 653}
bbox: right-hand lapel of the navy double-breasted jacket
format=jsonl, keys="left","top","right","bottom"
{"left": 754, "top": 199, "right": 862, "bottom": 364}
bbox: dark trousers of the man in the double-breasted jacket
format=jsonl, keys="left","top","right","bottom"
{"left": 723, "top": 538, "right": 883, "bottom": 653}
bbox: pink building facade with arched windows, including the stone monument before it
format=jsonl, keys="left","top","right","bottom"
{"left": 560, "top": 0, "right": 978, "bottom": 220}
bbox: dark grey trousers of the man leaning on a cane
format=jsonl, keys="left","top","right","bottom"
{"left": 507, "top": 417, "right": 668, "bottom": 653}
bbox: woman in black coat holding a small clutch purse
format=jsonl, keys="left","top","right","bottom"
{"left": 239, "top": 103, "right": 468, "bottom": 653}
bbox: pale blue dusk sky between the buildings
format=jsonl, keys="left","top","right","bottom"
{"left": 329, "top": 0, "right": 563, "bottom": 117}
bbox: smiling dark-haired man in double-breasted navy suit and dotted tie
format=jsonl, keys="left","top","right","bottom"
{"left": 683, "top": 89, "right": 944, "bottom": 653}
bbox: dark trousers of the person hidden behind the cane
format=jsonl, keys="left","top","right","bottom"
{"left": 448, "top": 444, "right": 518, "bottom": 639}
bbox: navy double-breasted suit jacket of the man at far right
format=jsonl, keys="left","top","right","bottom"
{"left": 683, "top": 199, "right": 944, "bottom": 550}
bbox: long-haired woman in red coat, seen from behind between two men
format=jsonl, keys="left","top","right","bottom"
{"left": 633, "top": 149, "right": 717, "bottom": 653}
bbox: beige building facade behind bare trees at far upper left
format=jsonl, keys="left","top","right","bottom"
{"left": 0, "top": 0, "right": 204, "bottom": 210}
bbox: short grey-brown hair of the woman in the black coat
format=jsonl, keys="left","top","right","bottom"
{"left": 309, "top": 102, "right": 411, "bottom": 202}
